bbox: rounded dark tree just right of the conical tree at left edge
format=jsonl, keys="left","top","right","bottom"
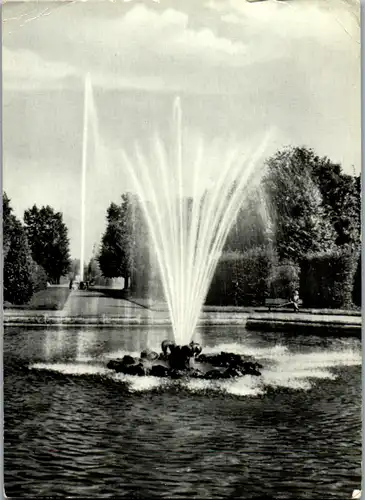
{"left": 24, "top": 205, "right": 70, "bottom": 283}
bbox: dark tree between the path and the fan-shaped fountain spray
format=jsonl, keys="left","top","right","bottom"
{"left": 98, "top": 193, "right": 134, "bottom": 288}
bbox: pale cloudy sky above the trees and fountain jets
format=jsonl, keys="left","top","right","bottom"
{"left": 3, "top": 0, "right": 361, "bottom": 258}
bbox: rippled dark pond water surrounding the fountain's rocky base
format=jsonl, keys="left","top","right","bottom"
{"left": 4, "top": 327, "right": 361, "bottom": 499}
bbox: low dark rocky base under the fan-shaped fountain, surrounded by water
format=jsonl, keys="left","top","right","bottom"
{"left": 107, "top": 341, "right": 262, "bottom": 380}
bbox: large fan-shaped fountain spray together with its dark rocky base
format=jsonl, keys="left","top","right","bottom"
{"left": 108, "top": 97, "right": 269, "bottom": 379}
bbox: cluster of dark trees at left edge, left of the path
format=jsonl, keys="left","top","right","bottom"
{"left": 3, "top": 193, "right": 70, "bottom": 304}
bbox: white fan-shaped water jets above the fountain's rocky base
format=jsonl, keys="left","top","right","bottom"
{"left": 122, "top": 98, "right": 269, "bottom": 344}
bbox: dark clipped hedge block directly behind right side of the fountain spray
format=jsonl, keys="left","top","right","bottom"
{"left": 206, "top": 248, "right": 274, "bottom": 306}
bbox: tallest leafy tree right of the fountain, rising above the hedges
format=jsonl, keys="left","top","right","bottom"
{"left": 264, "top": 148, "right": 336, "bottom": 262}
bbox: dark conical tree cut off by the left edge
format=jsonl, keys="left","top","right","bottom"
{"left": 3, "top": 193, "right": 34, "bottom": 304}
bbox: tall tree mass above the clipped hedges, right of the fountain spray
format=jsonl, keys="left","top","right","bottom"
{"left": 225, "top": 147, "right": 361, "bottom": 254}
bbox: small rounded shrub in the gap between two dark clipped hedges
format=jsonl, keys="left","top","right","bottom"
{"left": 269, "top": 262, "right": 300, "bottom": 299}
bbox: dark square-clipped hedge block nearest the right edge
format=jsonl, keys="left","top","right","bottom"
{"left": 300, "top": 249, "right": 358, "bottom": 309}
